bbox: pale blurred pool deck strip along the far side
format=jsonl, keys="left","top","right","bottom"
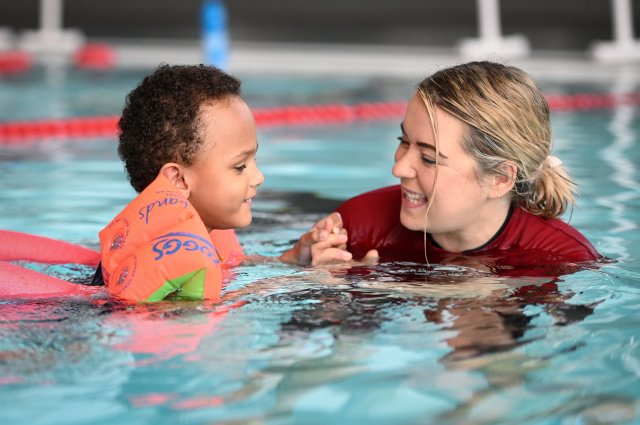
{"left": 105, "top": 40, "right": 640, "bottom": 85}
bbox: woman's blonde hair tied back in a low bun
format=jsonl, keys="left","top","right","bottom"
{"left": 418, "top": 62, "right": 576, "bottom": 218}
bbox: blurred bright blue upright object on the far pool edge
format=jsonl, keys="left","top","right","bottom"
{"left": 202, "top": 0, "right": 229, "bottom": 69}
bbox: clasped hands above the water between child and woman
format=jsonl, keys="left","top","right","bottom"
{"left": 280, "top": 212, "right": 352, "bottom": 266}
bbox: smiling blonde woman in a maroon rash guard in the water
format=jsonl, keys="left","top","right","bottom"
{"left": 292, "top": 62, "right": 601, "bottom": 266}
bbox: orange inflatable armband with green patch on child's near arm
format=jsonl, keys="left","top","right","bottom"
{"left": 100, "top": 175, "right": 222, "bottom": 301}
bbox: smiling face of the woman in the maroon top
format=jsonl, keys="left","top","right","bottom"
{"left": 393, "top": 94, "right": 505, "bottom": 252}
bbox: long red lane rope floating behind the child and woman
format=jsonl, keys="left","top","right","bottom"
{"left": 0, "top": 92, "right": 640, "bottom": 144}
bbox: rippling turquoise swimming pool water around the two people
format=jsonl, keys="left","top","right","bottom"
{"left": 0, "top": 64, "right": 640, "bottom": 424}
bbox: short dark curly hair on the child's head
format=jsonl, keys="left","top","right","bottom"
{"left": 118, "top": 65, "right": 240, "bottom": 192}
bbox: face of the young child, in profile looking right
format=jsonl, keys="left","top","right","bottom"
{"left": 185, "top": 96, "right": 264, "bottom": 231}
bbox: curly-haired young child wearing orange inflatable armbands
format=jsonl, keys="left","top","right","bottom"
{"left": 96, "top": 65, "right": 351, "bottom": 301}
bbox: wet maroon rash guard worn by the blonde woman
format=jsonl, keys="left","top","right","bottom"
{"left": 338, "top": 186, "right": 602, "bottom": 268}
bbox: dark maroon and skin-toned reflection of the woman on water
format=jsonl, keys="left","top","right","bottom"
{"left": 282, "top": 263, "right": 594, "bottom": 361}
